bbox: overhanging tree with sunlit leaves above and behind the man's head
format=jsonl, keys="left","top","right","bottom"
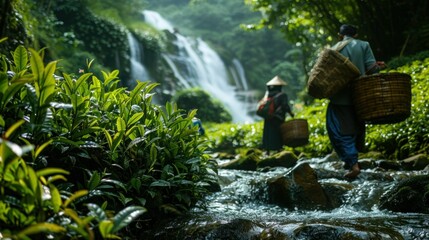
{"left": 245, "top": 0, "right": 429, "bottom": 64}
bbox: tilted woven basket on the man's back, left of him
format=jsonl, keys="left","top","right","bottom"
{"left": 307, "top": 48, "right": 360, "bottom": 98}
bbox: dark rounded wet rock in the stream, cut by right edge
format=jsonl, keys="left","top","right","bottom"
{"left": 379, "top": 175, "right": 429, "bottom": 213}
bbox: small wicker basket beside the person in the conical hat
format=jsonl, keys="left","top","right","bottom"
{"left": 280, "top": 119, "right": 309, "bottom": 147}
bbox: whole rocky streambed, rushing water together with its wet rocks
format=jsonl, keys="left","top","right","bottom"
{"left": 142, "top": 151, "right": 429, "bottom": 240}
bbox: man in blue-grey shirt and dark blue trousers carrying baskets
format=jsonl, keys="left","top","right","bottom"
{"left": 326, "top": 24, "right": 385, "bottom": 179}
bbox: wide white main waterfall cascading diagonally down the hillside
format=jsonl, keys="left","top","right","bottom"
{"left": 143, "top": 10, "right": 253, "bottom": 123}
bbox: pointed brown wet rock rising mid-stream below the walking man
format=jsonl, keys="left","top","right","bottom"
{"left": 268, "top": 163, "right": 331, "bottom": 209}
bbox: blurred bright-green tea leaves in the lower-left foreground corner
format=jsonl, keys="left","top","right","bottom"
{"left": 0, "top": 120, "right": 146, "bottom": 239}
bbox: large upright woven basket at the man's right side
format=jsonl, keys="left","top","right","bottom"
{"left": 353, "top": 73, "right": 411, "bottom": 124}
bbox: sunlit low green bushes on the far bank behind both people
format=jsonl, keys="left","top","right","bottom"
{"left": 207, "top": 58, "right": 429, "bottom": 159}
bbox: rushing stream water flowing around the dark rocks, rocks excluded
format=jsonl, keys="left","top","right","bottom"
{"left": 146, "top": 158, "right": 429, "bottom": 240}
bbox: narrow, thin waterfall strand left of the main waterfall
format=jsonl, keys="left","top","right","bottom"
{"left": 127, "top": 32, "right": 150, "bottom": 85}
